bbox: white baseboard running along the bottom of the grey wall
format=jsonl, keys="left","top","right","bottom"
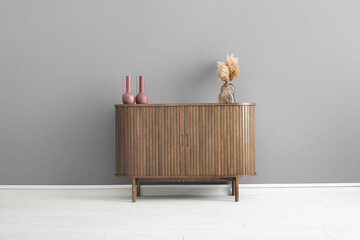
{"left": 0, "top": 183, "right": 360, "bottom": 189}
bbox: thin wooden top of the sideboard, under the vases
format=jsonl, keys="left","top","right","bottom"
{"left": 114, "top": 103, "right": 256, "bottom": 108}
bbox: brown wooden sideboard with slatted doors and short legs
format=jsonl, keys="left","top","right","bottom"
{"left": 115, "top": 103, "right": 256, "bottom": 202}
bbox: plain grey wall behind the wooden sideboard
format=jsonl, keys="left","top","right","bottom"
{"left": 0, "top": 0, "right": 360, "bottom": 184}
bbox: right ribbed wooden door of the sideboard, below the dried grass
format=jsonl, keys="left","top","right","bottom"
{"left": 184, "top": 105, "right": 255, "bottom": 176}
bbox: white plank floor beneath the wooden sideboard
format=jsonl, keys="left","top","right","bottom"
{"left": 0, "top": 185, "right": 360, "bottom": 240}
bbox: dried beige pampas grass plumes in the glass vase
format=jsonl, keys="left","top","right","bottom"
{"left": 217, "top": 54, "right": 240, "bottom": 82}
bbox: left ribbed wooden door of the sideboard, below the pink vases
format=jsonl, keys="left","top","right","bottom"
{"left": 116, "top": 106, "right": 185, "bottom": 177}
